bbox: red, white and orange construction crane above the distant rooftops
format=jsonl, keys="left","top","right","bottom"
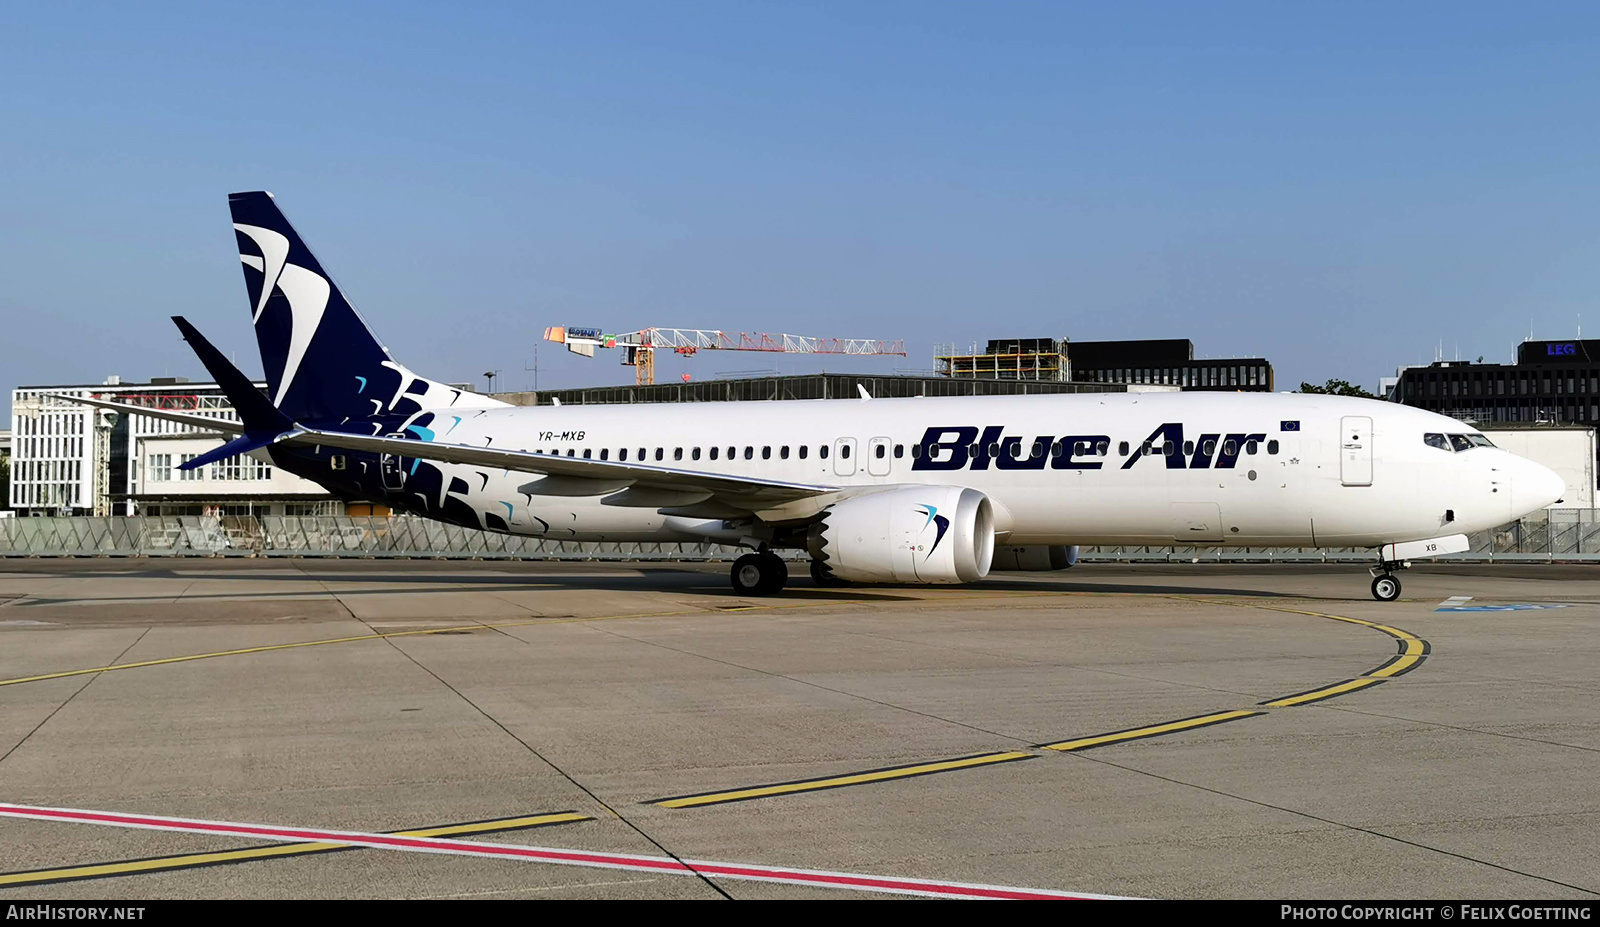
{"left": 544, "top": 325, "right": 906, "bottom": 386}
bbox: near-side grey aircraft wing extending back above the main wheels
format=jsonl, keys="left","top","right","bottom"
{"left": 282, "top": 429, "right": 838, "bottom": 504}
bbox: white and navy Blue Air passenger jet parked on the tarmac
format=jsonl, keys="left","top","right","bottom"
{"left": 65, "top": 192, "right": 1563, "bottom": 600}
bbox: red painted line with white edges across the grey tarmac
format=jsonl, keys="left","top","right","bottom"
{"left": 0, "top": 804, "right": 1112, "bottom": 900}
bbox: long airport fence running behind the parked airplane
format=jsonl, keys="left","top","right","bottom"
{"left": 0, "top": 509, "right": 1600, "bottom": 564}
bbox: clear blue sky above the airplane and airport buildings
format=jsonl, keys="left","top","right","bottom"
{"left": 0, "top": 0, "right": 1600, "bottom": 413}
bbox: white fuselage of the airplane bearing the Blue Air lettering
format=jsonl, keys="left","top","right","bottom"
{"left": 377, "top": 392, "right": 1560, "bottom": 546}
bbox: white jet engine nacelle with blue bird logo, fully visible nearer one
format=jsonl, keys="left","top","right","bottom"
{"left": 806, "top": 487, "right": 995, "bottom": 583}
